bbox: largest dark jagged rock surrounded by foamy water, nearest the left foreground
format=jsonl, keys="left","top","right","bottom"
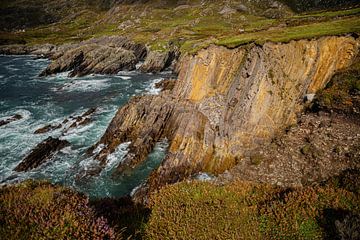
{"left": 14, "top": 137, "right": 70, "bottom": 172}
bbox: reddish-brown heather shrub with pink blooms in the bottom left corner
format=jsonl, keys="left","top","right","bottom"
{"left": 0, "top": 180, "right": 120, "bottom": 240}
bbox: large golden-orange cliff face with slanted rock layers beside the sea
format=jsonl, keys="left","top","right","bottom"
{"left": 90, "top": 34, "right": 360, "bottom": 198}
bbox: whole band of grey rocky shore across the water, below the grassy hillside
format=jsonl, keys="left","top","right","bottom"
{"left": 0, "top": 36, "right": 179, "bottom": 77}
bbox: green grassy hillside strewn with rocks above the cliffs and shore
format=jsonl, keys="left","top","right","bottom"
{"left": 0, "top": 1, "right": 360, "bottom": 52}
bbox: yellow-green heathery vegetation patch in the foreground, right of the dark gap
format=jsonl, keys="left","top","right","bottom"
{"left": 146, "top": 179, "right": 360, "bottom": 239}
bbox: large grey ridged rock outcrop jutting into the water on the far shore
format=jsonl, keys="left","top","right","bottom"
{"left": 40, "top": 37, "right": 147, "bottom": 77}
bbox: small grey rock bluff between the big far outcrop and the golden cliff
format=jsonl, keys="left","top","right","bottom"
{"left": 140, "top": 51, "right": 178, "bottom": 73}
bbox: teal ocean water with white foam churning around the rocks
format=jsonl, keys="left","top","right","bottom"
{"left": 0, "top": 56, "right": 170, "bottom": 198}
